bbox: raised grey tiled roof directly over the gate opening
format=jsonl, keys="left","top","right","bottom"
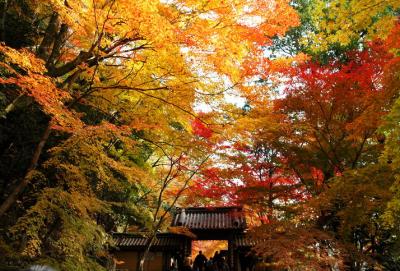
{"left": 171, "top": 207, "right": 246, "bottom": 230}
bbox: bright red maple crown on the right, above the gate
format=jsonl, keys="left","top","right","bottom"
{"left": 275, "top": 39, "right": 398, "bottom": 193}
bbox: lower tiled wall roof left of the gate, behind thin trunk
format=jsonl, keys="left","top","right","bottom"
{"left": 113, "top": 233, "right": 185, "bottom": 249}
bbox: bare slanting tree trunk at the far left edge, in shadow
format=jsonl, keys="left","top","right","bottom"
{"left": 0, "top": 121, "right": 52, "bottom": 217}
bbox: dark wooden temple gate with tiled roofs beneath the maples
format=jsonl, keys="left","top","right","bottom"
{"left": 114, "top": 206, "right": 254, "bottom": 271}
